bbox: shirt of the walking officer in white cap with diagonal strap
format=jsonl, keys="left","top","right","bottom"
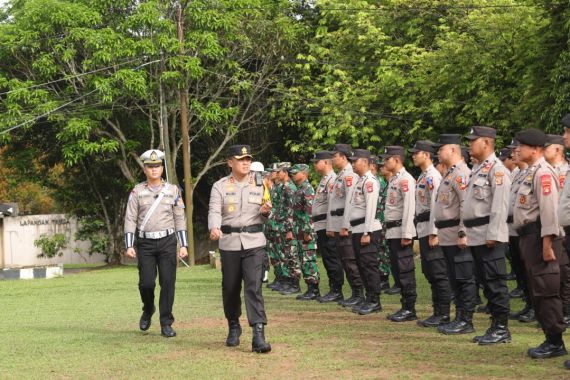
{"left": 125, "top": 181, "right": 186, "bottom": 234}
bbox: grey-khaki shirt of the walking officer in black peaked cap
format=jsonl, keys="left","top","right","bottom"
{"left": 208, "top": 174, "right": 267, "bottom": 251}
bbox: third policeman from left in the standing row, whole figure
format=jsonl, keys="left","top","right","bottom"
{"left": 348, "top": 149, "right": 382, "bottom": 315}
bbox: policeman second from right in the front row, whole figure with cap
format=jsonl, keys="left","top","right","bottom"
{"left": 459, "top": 126, "right": 511, "bottom": 345}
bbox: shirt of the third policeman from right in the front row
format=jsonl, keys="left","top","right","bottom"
{"left": 432, "top": 161, "right": 471, "bottom": 246}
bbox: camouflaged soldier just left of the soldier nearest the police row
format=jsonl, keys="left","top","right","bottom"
{"left": 273, "top": 162, "right": 301, "bottom": 295}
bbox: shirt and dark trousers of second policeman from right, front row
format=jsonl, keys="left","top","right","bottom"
{"left": 461, "top": 153, "right": 511, "bottom": 326}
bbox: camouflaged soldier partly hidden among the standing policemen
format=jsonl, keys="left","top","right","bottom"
{"left": 370, "top": 156, "right": 390, "bottom": 290}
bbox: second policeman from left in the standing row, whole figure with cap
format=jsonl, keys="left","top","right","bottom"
{"left": 327, "top": 144, "right": 364, "bottom": 307}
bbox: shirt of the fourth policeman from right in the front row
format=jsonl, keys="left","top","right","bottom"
{"left": 416, "top": 165, "right": 441, "bottom": 238}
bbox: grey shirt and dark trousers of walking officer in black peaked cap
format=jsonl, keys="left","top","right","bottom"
{"left": 208, "top": 174, "right": 267, "bottom": 326}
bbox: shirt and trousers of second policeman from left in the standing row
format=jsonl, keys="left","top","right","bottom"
{"left": 327, "top": 163, "right": 363, "bottom": 291}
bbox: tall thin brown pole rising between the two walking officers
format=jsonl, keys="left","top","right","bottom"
{"left": 177, "top": 0, "right": 196, "bottom": 265}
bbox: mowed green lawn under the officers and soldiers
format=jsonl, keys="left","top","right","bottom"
{"left": 0, "top": 266, "right": 570, "bottom": 379}
